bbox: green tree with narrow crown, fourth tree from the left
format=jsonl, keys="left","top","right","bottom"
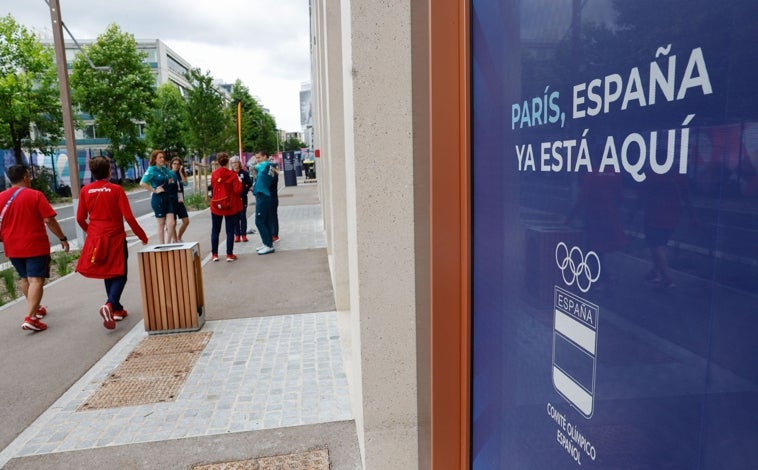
{"left": 185, "top": 69, "right": 227, "bottom": 159}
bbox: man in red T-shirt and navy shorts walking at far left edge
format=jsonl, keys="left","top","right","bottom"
{"left": 0, "top": 165, "right": 69, "bottom": 331}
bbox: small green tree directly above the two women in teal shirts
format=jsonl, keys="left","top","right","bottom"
{"left": 145, "top": 83, "right": 189, "bottom": 158}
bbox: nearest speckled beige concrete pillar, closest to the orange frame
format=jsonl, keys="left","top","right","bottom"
{"left": 342, "top": 0, "right": 418, "bottom": 469}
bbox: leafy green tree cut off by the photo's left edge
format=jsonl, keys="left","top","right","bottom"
{"left": 0, "top": 15, "right": 63, "bottom": 163}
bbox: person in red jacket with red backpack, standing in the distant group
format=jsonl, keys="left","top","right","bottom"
{"left": 210, "top": 152, "right": 242, "bottom": 262}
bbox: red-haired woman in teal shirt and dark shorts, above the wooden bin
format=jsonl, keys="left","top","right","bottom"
{"left": 140, "top": 150, "right": 177, "bottom": 244}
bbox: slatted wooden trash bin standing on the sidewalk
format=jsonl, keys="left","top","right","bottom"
{"left": 139, "top": 242, "right": 205, "bottom": 334}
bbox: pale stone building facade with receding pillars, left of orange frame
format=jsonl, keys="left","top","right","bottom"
{"left": 312, "top": 0, "right": 429, "bottom": 470}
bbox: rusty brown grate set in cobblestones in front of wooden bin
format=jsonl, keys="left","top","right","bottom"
{"left": 77, "top": 332, "right": 212, "bottom": 411}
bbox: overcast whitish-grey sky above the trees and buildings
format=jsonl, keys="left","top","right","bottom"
{"left": 0, "top": 0, "right": 310, "bottom": 132}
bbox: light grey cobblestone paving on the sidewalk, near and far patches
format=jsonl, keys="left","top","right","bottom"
{"left": 0, "top": 185, "right": 360, "bottom": 469}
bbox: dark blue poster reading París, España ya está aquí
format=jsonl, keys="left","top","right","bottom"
{"left": 471, "top": 0, "right": 758, "bottom": 470}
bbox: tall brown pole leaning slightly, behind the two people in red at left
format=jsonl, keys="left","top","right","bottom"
{"left": 48, "top": 0, "right": 84, "bottom": 248}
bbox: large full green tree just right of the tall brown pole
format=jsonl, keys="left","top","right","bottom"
{"left": 71, "top": 24, "right": 155, "bottom": 178}
